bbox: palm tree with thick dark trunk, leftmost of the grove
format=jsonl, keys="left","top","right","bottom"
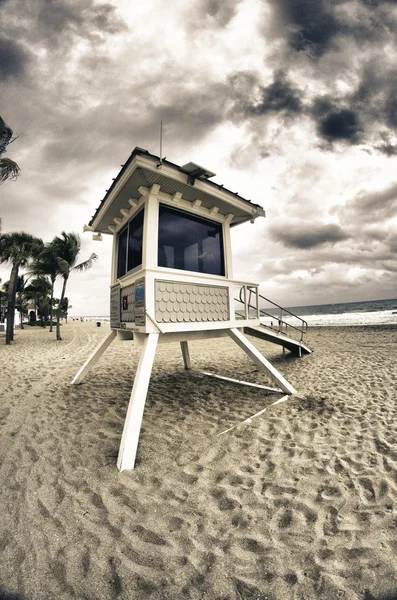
{"left": 0, "top": 231, "right": 43, "bottom": 345}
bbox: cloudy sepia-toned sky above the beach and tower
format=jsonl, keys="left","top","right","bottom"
{"left": 0, "top": 0, "right": 397, "bottom": 315}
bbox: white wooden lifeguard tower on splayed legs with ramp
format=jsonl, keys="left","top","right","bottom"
{"left": 71, "top": 147, "right": 309, "bottom": 470}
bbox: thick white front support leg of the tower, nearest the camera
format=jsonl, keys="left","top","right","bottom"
{"left": 117, "top": 333, "right": 159, "bottom": 471}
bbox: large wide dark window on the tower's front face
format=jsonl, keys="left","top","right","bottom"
{"left": 158, "top": 205, "right": 225, "bottom": 275}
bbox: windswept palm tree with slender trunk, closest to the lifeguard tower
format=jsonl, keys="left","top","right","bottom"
{"left": 51, "top": 231, "right": 98, "bottom": 340}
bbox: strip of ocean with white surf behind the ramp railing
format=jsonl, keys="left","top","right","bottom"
{"left": 261, "top": 298, "right": 397, "bottom": 327}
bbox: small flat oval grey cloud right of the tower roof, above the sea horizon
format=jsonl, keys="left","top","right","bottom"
{"left": 270, "top": 221, "right": 349, "bottom": 249}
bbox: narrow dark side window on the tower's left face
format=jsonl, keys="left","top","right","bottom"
{"left": 117, "top": 210, "right": 143, "bottom": 278}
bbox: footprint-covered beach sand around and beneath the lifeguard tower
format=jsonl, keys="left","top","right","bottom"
{"left": 0, "top": 322, "right": 397, "bottom": 600}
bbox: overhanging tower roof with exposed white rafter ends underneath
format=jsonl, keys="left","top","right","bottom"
{"left": 89, "top": 148, "right": 266, "bottom": 233}
